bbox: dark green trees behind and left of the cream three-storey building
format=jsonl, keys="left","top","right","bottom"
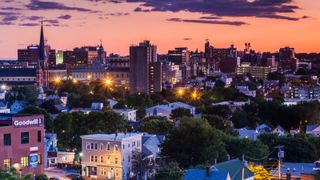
{"left": 54, "top": 111, "right": 130, "bottom": 151}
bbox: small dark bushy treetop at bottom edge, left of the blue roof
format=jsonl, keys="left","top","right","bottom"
{"left": 155, "top": 162, "right": 183, "bottom": 180}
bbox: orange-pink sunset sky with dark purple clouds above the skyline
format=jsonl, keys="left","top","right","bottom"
{"left": 0, "top": 0, "right": 320, "bottom": 59}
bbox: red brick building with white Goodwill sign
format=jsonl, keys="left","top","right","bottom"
{"left": 0, "top": 114, "right": 44, "bottom": 174}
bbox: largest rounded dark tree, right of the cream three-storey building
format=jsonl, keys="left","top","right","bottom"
{"left": 162, "top": 118, "right": 226, "bottom": 167}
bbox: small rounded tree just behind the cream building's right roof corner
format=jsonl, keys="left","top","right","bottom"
{"left": 139, "top": 119, "right": 174, "bottom": 135}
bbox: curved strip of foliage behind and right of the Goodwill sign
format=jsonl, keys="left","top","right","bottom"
{"left": 21, "top": 106, "right": 53, "bottom": 132}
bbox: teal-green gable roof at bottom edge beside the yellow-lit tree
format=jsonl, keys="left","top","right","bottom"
{"left": 212, "top": 159, "right": 254, "bottom": 180}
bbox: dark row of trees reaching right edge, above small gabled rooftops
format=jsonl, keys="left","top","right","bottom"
{"left": 231, "top": 99, "right": 320, "bottom": 131}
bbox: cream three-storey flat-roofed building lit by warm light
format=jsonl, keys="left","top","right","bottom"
{"left": 81, "top": 133, "right": 143, "bottom": 180}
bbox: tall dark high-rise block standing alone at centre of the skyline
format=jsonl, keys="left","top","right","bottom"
{"left": 130, "top": 41, "right": 162, "bottom": 94}
